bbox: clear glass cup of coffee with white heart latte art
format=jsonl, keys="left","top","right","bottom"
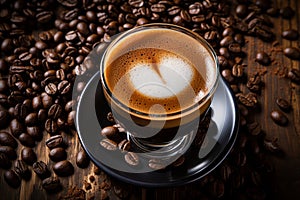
{"left": 100, "top": 23, "right": 219, "bottom": 156}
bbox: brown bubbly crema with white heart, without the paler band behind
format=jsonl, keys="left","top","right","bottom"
{"left": 105, "top": 48, "right": 207, "bottom": 114}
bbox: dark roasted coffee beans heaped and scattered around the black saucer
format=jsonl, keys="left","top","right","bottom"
{"left": 0, "top": 0, "right": 300, "bottom": 199}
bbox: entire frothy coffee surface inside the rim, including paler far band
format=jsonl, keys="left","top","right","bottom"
{"left": 104, "top": 29, "right": 216, "bottom": 114}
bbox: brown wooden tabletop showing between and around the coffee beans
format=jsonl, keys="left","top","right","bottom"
{"left": 0, "top": 0, "right": 300, "bottom": 200}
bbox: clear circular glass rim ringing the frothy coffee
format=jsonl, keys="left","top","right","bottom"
{"left": 100, "top": 23, "right": 219, "bottom": 120}
